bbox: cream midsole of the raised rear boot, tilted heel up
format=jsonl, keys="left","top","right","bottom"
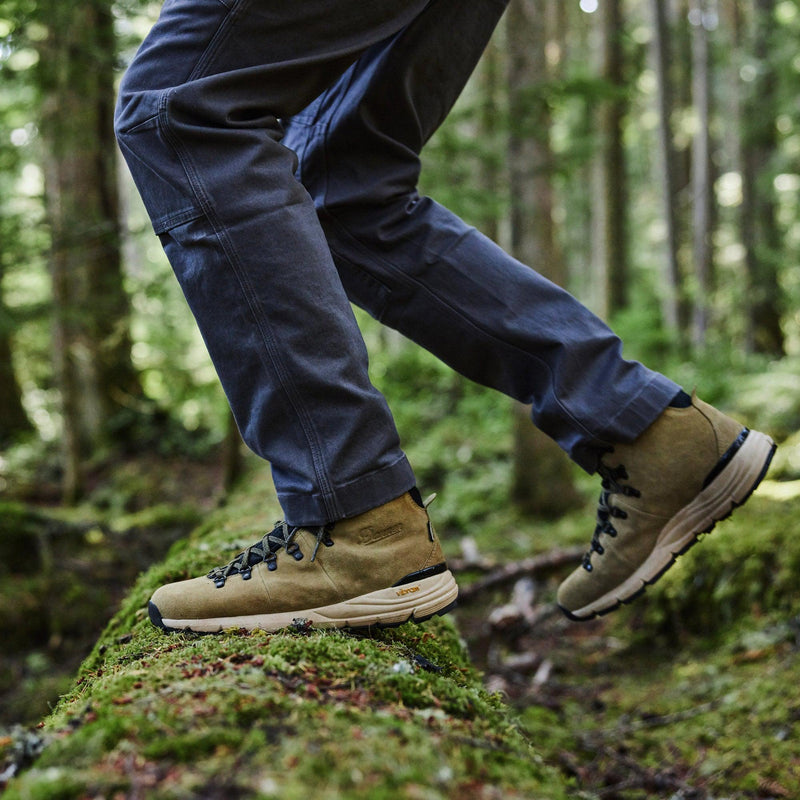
{"left": 571, "top": 431, "right": 774, "bottom": 618}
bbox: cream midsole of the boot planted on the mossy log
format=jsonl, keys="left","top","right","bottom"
{"left": 162, "top": 570, "right": 458, "bottom": 633}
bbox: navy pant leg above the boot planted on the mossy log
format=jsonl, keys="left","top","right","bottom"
{"left": 116, "top": 0, "right": 434, "bottom": 525}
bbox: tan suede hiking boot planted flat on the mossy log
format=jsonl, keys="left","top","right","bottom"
{"left": 150, "top": 489, "right": 458, "bottom": 633}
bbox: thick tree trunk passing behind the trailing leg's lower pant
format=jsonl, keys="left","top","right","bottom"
{"left": 506, "top": 0, "right": 576, "bottom": 516}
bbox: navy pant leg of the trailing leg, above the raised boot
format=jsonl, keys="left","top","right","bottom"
{"left": 285, "top": 0, "right": 680, "bottom": 471}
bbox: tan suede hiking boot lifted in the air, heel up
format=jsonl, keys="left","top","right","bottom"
{"left": 558, "top": 396, "right": 775, "bottom": 620}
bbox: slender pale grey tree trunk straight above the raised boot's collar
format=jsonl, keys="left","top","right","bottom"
{"left": 689, "top": 0, "right": 713, "bottom": 348}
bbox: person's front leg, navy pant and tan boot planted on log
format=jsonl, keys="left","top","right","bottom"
{"left": 116, "top": 0, "right": 457, "bottom": 630}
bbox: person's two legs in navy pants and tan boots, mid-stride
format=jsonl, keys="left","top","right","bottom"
{"left": 116, "top": 0, "right": 773, "bottom": 631}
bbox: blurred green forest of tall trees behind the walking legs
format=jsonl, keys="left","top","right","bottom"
{"left": 0, "top": 0, "right": 800, "bottom": 772}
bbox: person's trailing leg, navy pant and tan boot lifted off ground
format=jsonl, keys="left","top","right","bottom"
{"left": 286, "top": 0, "right": 774, "bottom": 619}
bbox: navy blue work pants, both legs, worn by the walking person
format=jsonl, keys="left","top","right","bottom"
{"left": 116, "top": 0, "right": 679, "bottom": 525}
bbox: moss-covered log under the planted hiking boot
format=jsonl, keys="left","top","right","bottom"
{"left": 5, "top": 478, "right": 574, "bottom": 800}
